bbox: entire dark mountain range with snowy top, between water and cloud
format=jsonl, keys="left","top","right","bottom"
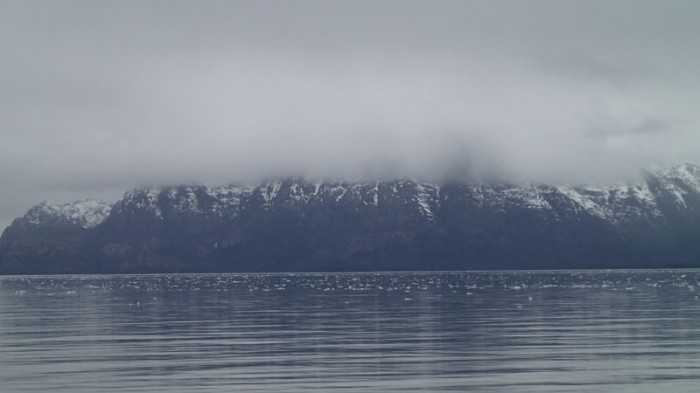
{"left": 0, "top": 165, "right": 700, "bottom": 274}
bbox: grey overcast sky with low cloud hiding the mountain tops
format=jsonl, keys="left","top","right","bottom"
{"left": 0, "top": 0, "right": 700, "bottom": 228}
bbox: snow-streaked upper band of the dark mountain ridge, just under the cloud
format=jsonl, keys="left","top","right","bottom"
{"left": 16, "top": 164, "right": 700, "bottom": 229}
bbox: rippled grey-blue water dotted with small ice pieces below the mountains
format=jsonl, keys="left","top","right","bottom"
{"left": 0, "top": 270, "right": 700, "bottom": 392}
